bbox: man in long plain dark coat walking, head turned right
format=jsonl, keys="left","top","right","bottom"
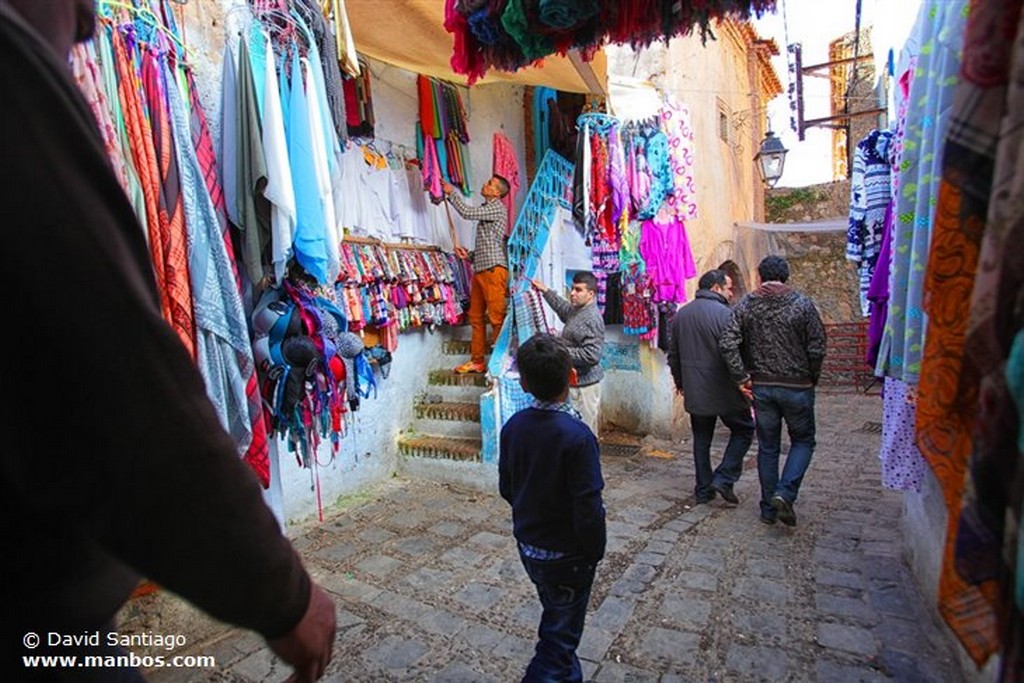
{"left": 668, "top": 270, "right": 754, "bottom": 505}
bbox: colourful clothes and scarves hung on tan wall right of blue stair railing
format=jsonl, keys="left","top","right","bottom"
{"left": 572, "top": 104, "right": 697, "bottom": 339}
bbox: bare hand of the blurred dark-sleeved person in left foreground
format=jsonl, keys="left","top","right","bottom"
{"left": 267, "top": 584, "right": 336, "bottom": 683}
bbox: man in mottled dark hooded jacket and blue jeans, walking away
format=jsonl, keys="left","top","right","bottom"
{"left": 719, "top": 256, "right": 825, "bottom": 526}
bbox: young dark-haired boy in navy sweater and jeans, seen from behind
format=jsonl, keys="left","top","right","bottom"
{"left": 498, "top": 334, "right": 605, "bottom": 681}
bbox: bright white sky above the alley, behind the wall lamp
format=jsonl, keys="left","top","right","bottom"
{"left": 754, "top": 0, "right": 921, "bottom": 187}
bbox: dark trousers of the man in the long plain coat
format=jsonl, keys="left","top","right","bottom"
{"left": 690, "top": 410, "right": 754, "bottom": 501}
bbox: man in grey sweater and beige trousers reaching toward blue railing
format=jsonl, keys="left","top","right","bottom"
{"left": 530, "top": 271, "right": 604, "bottom": 436}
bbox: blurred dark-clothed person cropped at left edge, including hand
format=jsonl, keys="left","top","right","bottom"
{"left": 0, "top": 0, "right": 335, "bottom": 681}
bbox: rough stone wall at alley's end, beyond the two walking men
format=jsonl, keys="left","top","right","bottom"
{"left": 765, "top": 180, "right": 861, "bottom": 324}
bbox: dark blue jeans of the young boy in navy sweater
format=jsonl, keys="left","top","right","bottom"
{"left": 519, "top": 553, "right": 596, "bottom": 683}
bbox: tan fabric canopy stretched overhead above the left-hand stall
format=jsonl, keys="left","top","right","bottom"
{"left": 345, "top": 0, "right": 607, "bottom": 94}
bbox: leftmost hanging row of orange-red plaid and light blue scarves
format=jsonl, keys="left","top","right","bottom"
{"left": 73, "top": 2, "right": 269, "bottom": 486}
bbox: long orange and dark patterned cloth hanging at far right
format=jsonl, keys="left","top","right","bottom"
{"left": 916, "top": 0, "right": 1022, "bottom": 665}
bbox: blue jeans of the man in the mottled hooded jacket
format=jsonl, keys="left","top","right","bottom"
{"left": 754, "top": 384, "right": 814, "bottom": 518}
